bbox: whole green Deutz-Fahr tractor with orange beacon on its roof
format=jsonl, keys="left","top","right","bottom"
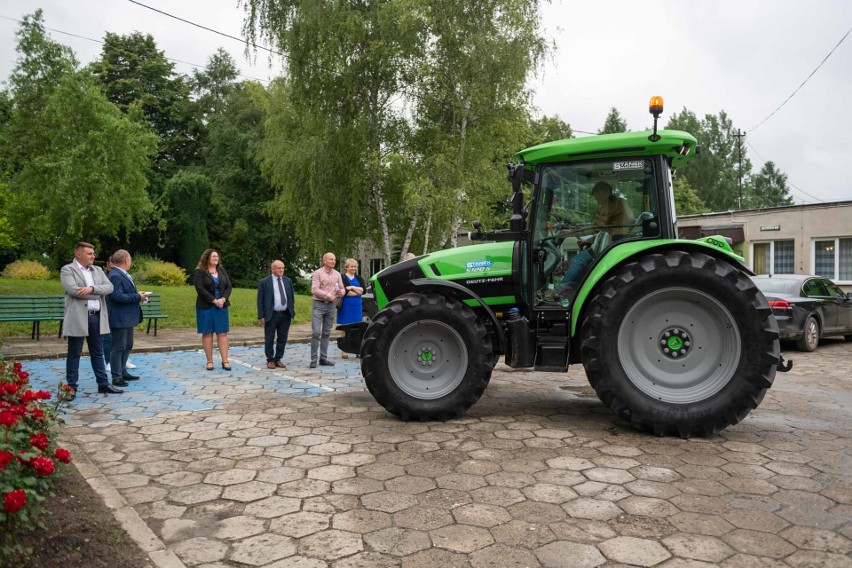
{"left": 338, "top": 97, "right": 786, "bottom": 438}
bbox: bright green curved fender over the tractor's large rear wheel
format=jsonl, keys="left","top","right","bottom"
{"left": 571, "top": 236, "right": 754, "bottom": 337}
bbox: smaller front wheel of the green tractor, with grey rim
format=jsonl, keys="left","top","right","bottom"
{"left": 361, "top": 293, "right": 495, "bottom": 421}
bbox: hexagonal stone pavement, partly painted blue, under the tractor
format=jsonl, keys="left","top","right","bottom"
{"left": 18, "top": 340, "right": 852, "bottom": 568}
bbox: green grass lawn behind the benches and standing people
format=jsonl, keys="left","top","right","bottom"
{"left": 0, "top": 278, "right": 311, "bottom": 338}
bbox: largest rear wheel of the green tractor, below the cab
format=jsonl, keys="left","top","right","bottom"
{"left": 581, "top": 251, "right": 780, "bottom": 438}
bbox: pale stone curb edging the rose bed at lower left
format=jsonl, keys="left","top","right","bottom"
{"left": 62, "top": 427, "right": 186, "bottom": 568}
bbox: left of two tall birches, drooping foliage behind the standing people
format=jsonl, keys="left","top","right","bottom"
{"left": 245, "top": 0, "right": 421, "bottom": 259}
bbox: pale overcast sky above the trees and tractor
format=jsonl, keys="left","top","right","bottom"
{"left": 0, "top": 0, "right": 852, "bottom": 203}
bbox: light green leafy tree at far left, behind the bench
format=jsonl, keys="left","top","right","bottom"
{"left": 4, "top": 13, "right": 156, "bottom": 262}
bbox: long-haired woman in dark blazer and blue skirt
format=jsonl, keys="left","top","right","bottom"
{"left": 192, "top": 249, "right": 232, "bottom": 371}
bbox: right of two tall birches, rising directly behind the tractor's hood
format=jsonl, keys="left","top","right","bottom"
{"left": 408, "top": 0, "right": 546, "bottom": 245}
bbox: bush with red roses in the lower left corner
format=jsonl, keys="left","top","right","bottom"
{"left": 0, "top": 360, "right": 71, "bottom": 558}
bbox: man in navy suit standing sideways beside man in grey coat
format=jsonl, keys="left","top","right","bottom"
{"left": 107, "top": 249, "right": 148, "bottom": 387}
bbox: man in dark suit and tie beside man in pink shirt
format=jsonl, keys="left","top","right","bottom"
{"left": 257, "top": 260, "right": 296, "bottom": 369}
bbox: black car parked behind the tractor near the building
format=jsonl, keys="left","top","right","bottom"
{"left": 752, "top": 274, "right": 852, "bottom": 351}
